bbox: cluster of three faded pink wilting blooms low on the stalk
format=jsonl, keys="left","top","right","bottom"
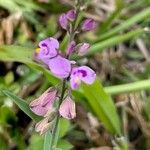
{"left": 29, "top": 88, "right": 76, "bottom": 134}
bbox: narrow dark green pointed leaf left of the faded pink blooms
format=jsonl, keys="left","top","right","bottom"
{"left": 2, "top": 90, "right": 42, "bottom": 121}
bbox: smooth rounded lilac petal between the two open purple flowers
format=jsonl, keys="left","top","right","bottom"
{"left": 48, "top": 55, "right": 71, "bottom": 78}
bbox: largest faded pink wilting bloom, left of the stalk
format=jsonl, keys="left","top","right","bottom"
{"left": 29, "top": 88, "right": 57, "bottom": 116}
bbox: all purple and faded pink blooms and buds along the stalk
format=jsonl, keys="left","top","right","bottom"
{"left": 30, "top": 10, "right": 96, "bottom": 134}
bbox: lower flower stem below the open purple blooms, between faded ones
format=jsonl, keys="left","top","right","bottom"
{"left": 50, "top": 79, "right": 66, "bottom": 150}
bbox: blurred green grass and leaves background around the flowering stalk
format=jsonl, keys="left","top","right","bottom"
{"left": 0, "top": 0, "right": 150, "bottom": 150}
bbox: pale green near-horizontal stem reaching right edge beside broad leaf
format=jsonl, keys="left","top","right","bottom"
{"left": 104, "top": 79, "right": 150, "bottom": 95}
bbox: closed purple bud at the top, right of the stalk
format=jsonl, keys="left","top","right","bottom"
{"left": 81, "top": 18, "right": 96, "bottom": 31}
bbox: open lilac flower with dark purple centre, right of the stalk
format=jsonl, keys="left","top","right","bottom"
{"left": 70, "top": 66, "right": 96, "bottom": 89}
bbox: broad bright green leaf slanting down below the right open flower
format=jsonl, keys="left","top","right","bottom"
{"left": 82, "top": 80, "right": 121, "bottom": 134}
